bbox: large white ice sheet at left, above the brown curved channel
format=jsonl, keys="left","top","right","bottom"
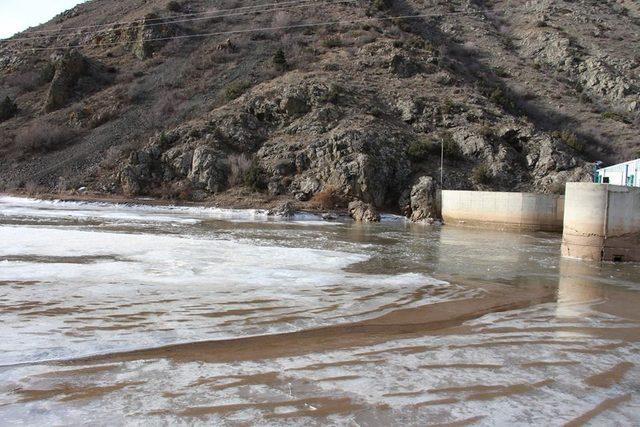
{"left": 0, "top": 226, "right": 459, "bottom": 364}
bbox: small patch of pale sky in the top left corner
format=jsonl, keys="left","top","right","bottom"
{"left": 0, "top": 0, "right": 86, "bottom": 38}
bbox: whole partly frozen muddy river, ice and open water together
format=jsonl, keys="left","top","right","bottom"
{"left": 0, "top": 197, "right": 640, "bottom": 426}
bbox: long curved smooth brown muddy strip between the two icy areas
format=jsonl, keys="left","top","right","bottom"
{"left": 64, "top": 284, "right": 555, "bottom": 364}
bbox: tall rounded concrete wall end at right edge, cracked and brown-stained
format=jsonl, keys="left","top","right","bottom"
{"left": 562, "top": 183, "right": 640, "bottom": 261}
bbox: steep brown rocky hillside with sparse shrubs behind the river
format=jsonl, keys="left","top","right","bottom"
{"left": 0, "top": 0, "right": 640, "bottom": 219}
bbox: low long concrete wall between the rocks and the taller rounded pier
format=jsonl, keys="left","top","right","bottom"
{"left": 442, "top": 190, "right": 564, "bottom": 232}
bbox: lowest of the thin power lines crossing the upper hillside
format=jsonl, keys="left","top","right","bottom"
{"left": 5, "top": 9, "right": 506, "bottom": 51}
